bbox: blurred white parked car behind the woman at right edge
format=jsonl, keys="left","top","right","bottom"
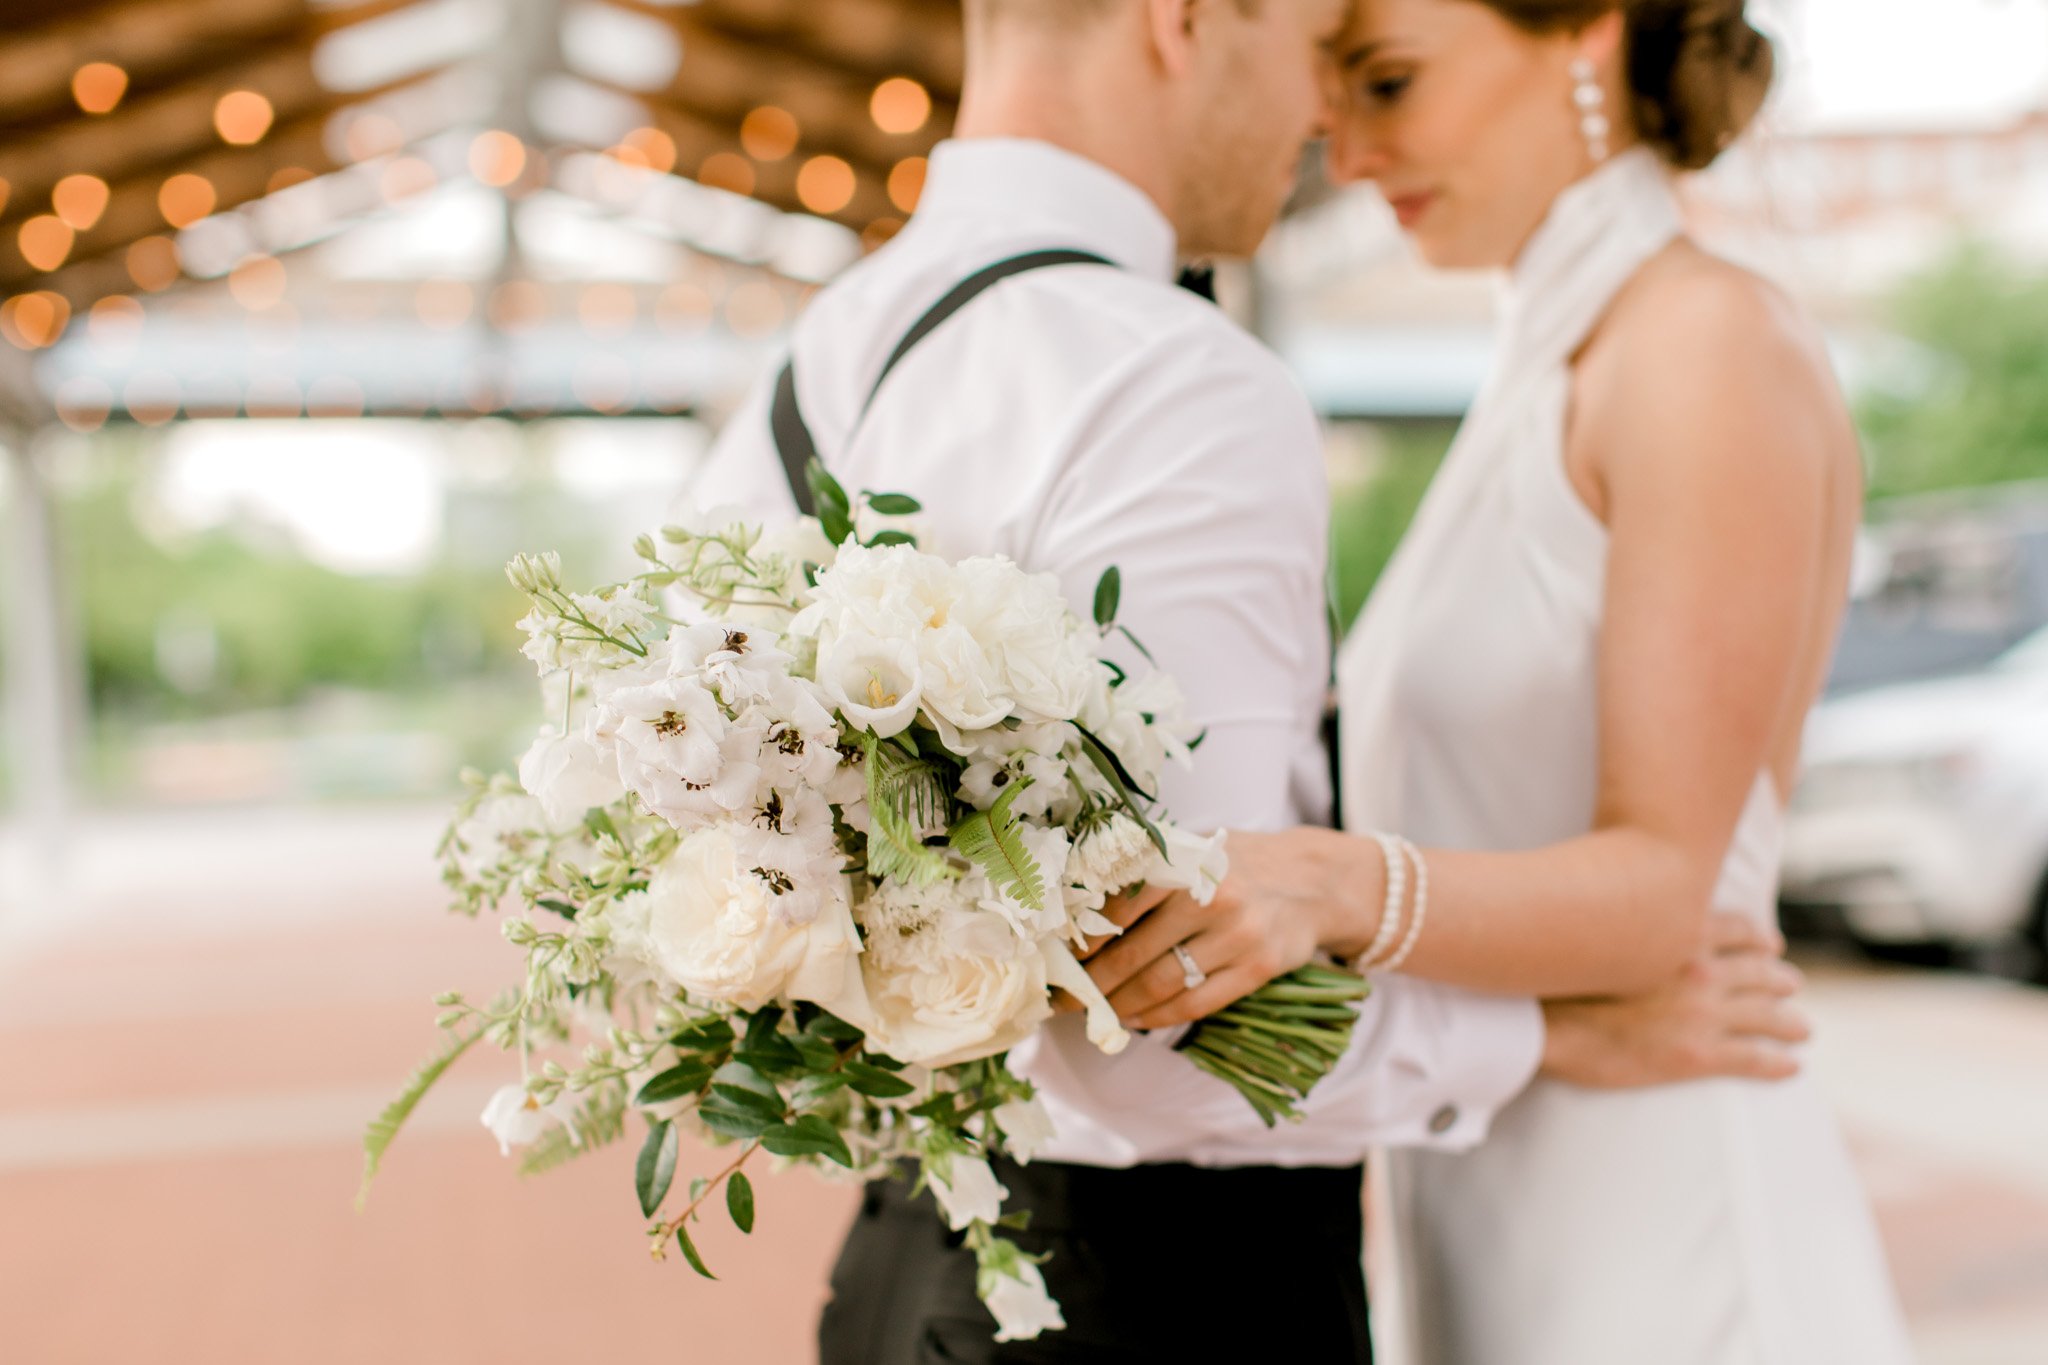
{"left": 1782, "top": 630, "right": 2048, "bottom": 954}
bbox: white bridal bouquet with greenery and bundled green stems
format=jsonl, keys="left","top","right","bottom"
{"left": 365, "top": 467, "right": 1364, "bottom": 1340}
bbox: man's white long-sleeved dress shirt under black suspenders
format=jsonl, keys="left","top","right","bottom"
{"left": 686, "top": 139, "right": 1542, "bottom": 1166}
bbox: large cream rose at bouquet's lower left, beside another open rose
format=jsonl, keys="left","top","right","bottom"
{"left": 647, "top": 825, "right": 860, "bottom": 1009}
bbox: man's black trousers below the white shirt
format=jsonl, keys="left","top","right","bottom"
{"left": 819, "top": 1162, "right": 1372, "bottom": 1365}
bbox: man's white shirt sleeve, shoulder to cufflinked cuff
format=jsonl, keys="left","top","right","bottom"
{"left": 1007, "top": 317, "right": 1542, "bottom": 1164}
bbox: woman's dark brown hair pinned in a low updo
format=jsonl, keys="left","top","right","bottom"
{"left": 1479, "top": 0, "right": 1776, "bottom": 170}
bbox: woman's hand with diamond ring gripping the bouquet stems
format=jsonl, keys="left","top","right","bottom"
{"left": 1083, "top": 829, "right": 1341, "bottom": 1029}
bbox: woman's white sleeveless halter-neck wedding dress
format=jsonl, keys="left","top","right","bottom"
{"left": 1339, "top": 149, "right": 1911, "bottom": 1365}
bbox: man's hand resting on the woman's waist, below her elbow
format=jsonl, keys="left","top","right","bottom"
{"left": 1542, "top": 913, "right": 1812, "bottom": 1089}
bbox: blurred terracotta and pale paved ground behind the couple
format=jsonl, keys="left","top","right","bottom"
{"left": 0, "top": 810, "right": 2048, "bottom": 1365}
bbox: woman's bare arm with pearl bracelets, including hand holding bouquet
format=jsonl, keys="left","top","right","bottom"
{"left": 1092, "top": 278, "right": 1855, "bottom": 1027}
